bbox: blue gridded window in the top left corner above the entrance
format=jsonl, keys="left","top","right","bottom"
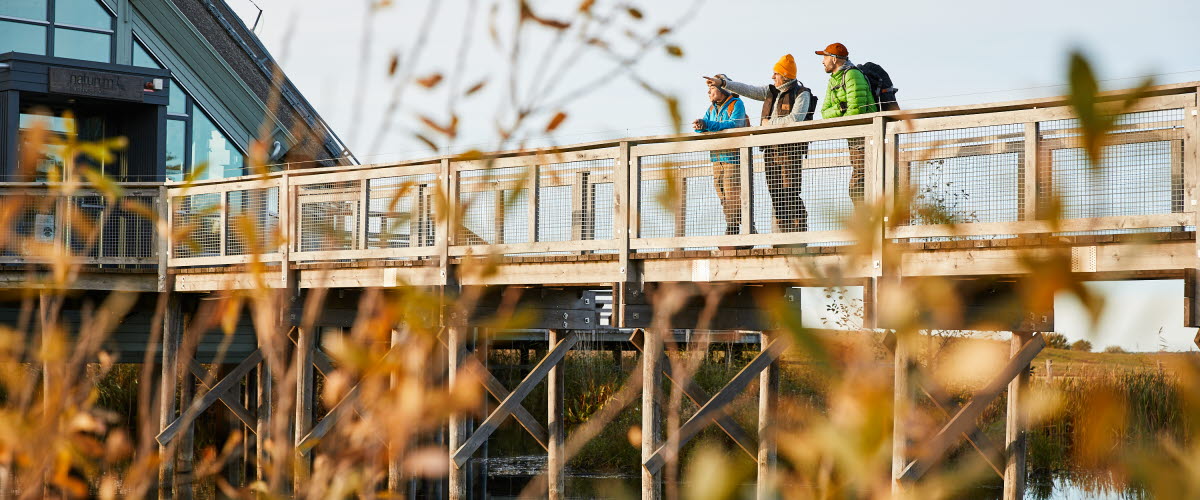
{"left": 0, "top": 0, "right": 116, "bottom": 62}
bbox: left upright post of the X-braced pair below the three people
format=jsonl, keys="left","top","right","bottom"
{"left": 642, "top": 329, "right": 662, "bottom": 500}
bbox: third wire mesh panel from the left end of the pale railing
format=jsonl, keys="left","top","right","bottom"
{"left": 296, "top": 181, "right": 362, "bottom": 252}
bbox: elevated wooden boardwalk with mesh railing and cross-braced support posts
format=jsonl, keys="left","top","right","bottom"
{"left": 0, "top": 83, "right": 1200, "bottom": 499}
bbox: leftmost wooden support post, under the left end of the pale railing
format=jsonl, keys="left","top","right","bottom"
{"left": 158, "top": 291, "right": 184, "bottom": 499}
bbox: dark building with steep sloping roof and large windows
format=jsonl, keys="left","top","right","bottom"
{"left": 0, "top": 0, "right": 355, "bottom": 181}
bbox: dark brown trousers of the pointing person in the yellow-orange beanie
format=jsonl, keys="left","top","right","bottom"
{"left": 762, "top": 143, "right": 809, "bottom": 233}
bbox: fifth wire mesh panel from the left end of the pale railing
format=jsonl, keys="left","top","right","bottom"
{"left": 457, "top": 167, "right": 534, "bottom": 245}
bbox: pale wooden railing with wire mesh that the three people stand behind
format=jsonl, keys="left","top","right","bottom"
{"left": 150, "top": 84, "right": 1200, "bottom": 272}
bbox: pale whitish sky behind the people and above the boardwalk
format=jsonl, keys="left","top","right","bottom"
{"left": 227, "top": 0, "right": 1200, "bottom": 350}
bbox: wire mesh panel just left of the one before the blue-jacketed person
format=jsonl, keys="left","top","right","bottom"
{"left": 538, "top": 158, "right": 616, "bottom": 241}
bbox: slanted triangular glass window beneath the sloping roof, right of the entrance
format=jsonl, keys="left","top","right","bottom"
{"left": 132, "top": 37, "right": 246, "bottom": 181}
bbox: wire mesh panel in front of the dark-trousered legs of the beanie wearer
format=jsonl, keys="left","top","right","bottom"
{"left": 752, "top": 138, "right": 866, "bottom": 234}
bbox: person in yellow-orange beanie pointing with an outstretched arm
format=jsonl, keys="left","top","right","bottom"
{"left": 704, "top": 54, "right": 817, "bottom": 233}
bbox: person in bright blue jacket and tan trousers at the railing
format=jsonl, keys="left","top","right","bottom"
{"left": 691, "top": 84, "right": 750, "bottom": 235}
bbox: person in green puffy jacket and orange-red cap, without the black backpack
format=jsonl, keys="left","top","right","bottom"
{"left": 816, "top": 43, "right": 880, "bottom": 209}
